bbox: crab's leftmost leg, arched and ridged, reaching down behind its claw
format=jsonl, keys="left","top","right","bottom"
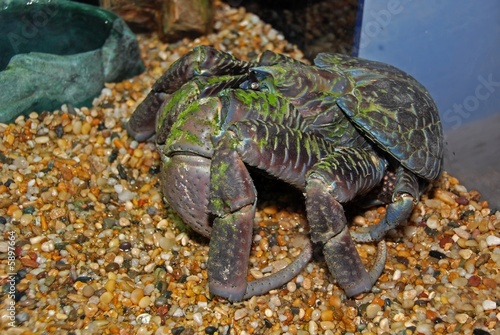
{"left": 127, "top": 46, "right": 252, "bottom": 141}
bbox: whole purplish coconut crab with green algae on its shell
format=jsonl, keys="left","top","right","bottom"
{"left": 127, "top": 46, "right": 443, "bottom": 301}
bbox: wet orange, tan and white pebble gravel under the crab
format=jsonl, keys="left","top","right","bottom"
{"left": 0, "top": 1, "right": 500, "bottom": 335}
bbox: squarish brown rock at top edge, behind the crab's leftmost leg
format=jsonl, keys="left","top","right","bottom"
{"left": 162, "top": 0, "right": 213, "bottom": 42}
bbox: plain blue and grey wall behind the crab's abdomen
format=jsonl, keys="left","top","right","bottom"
{"left": 355, "top": 0, "right": 500, "bottom": 206}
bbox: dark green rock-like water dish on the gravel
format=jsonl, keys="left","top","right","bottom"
{"left": 0, "top": 0, "right": 144, "bottom": 122}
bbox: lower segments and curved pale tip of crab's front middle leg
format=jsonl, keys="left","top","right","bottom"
{"left": 208, "top": 136, "right": 312, "bottom": 301}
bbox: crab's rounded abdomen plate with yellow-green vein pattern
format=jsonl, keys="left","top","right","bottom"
{"left": 315, "top": 54, "right": 443, "bottom": 179}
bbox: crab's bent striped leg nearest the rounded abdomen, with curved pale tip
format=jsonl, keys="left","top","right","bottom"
{"left": 306, "top": 148, "right": 386, "bottom": 296}
